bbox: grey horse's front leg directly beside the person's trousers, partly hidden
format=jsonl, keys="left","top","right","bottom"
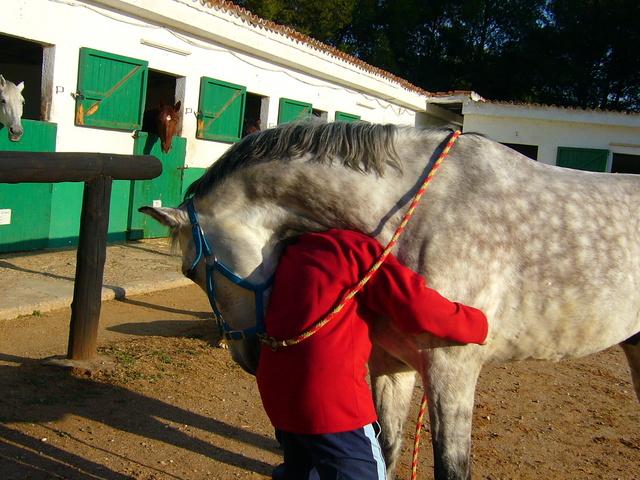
{"left": 369, "top": 347, "right": 416, "bottom": 479}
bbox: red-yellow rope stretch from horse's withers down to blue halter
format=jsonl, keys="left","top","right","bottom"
{"left": 261, "top": 130, "right": 462, "bottom": 350}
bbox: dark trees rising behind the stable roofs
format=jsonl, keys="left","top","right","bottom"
{"left": 237, "top": 0, "right": 640, "bottom": 111}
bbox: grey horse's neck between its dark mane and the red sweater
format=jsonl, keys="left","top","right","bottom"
{"left": 234, "top": 133, "right": 444, "bottom": 239}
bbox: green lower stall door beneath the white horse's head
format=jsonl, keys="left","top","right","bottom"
{"left": 0, "top": 119, "right": 57, "bottom": 253}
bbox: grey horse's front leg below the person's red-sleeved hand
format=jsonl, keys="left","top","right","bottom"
{"left": 423, "top": 347, "right": 482, "bottom": 480}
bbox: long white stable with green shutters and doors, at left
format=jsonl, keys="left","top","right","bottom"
{"left": 0, "top": 0, "right": 428, "bottom": 252}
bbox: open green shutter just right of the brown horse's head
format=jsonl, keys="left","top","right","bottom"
{"left": 196, "top": 77, "right": 247, "bottom": 142}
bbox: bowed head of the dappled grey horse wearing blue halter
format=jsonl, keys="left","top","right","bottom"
{"left": 140, "top": 188, "right": 278, "bottom": 374}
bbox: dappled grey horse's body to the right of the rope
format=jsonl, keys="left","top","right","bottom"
{"left": 409, "top": 137, "right": 640, "bottom": 360}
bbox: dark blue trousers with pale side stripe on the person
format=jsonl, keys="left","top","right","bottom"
{"left": 273, "top": 423, "right": 386, "bottom": 480}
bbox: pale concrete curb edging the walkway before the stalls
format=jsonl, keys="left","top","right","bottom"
{"left": 0, "top": 274, "right": 194, "bottom": 320}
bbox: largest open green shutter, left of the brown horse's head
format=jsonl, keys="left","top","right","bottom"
{"left": 76, "top": 48, "right": 148, "bottom": 130}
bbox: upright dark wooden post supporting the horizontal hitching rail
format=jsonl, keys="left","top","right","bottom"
{"left": 67, "top": 175, "right": 112, "bottom": 360}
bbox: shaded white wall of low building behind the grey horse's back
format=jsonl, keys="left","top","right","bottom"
{"left": 462, "top": 102, "right": 640, "bottom": 165}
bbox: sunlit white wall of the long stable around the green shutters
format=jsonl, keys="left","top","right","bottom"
{"left": 0, "top": 0, "right": 425, "bottom": 167}
